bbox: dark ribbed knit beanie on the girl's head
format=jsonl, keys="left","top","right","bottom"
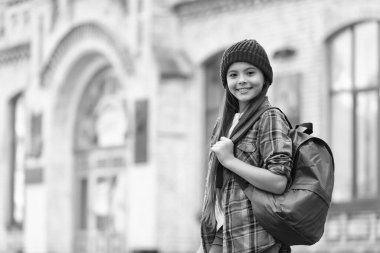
{"left": 220, "top": 40, "right": 273, "bottom": 87}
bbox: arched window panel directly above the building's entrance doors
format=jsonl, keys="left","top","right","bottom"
{"left": 75, "top": 68, "right": 128, "bottom": 150}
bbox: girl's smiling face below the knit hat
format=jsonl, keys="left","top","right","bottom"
{"left": 227, "top": 62, "right": 265, "bottom": 112}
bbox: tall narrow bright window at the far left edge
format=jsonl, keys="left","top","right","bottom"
{"left": 10, "top": 94, "right": 26, "bottom": 229}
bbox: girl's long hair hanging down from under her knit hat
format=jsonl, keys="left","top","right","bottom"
{"left": 201, "top": 81, "right": 270, "bottom": 228}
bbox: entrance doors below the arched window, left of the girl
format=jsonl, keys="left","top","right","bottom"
{"left": 75, "top": 148, "right": 126, "bottom": 253}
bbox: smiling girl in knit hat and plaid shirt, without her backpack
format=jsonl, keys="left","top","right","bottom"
{"left": 199, "top": 40, "right": 292, "bottom": 253}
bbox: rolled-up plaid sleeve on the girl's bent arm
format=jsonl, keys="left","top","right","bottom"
{"left": 259, "top": 109, "right": 292, "bottom": 181}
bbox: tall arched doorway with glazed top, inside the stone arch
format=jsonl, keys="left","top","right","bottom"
{"left": 73, "top": 67, "right": 128, "bottom": 253}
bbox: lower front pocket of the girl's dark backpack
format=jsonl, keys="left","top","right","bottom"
{"left": 247, "top": 187, "right": 328, "bottom": 245}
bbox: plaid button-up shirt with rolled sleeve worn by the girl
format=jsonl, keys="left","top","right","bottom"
{"left": 201, "top": 109, "right": 292, "bottom": 253}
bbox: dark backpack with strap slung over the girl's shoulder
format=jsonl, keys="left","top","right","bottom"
{"left": 232, "top": 107, "right": 334, "bottom": 246}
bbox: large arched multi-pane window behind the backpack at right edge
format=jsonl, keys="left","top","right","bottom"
{"left": 327, "top": 21, "right": 380, "bottom": 206}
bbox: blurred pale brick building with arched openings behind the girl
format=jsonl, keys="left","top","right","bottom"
{"left": 0, "top": 0, "right": 380, "bottom": 253}
